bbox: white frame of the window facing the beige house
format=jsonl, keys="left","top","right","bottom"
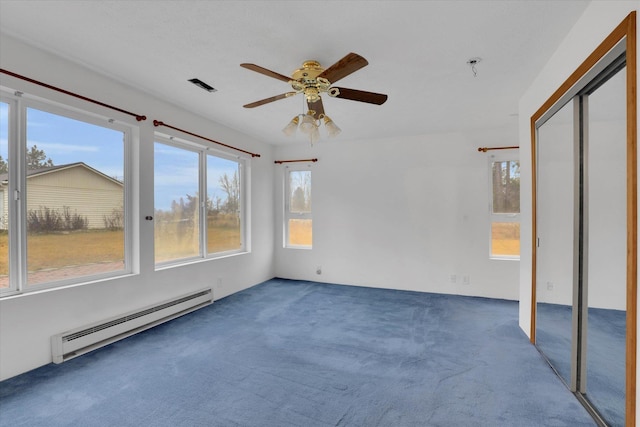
{"left": 0, "top": 87, "right": 139, "bottom": 298}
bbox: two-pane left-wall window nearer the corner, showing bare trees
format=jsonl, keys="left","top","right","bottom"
{"left": 154, "top": 136, "right": 245, "bottom": 265}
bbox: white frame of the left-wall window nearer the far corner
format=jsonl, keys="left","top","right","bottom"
{"left": 153, "top": 132, "right": 250, "bottom": 270}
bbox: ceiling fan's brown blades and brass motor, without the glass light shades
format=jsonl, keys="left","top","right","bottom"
{"left": 240, "top": 53, "right": 387, "bottom": 127}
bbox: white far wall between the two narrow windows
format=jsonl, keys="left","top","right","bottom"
{"left": 275, "top": 129, "right": 519, "bottom": 299}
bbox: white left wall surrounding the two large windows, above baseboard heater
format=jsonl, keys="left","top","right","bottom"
{"left": 0, "top": 34, "right": 274, "bottom": 380}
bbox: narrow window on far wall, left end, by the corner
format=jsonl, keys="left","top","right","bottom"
{"left": 285, "top": 169, "right": 313, "bottom": 248}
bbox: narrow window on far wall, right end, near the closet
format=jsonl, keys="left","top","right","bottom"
{"left": 491, "top": 158, "right": 520, "bottom": 259}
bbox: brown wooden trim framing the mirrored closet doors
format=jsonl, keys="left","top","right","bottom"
{"left": 530, "top": 12, "right": 638, "bottom": 426}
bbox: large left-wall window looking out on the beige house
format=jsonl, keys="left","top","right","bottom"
{"left": 0, "top": 94, "right": 131, "bottom": 293}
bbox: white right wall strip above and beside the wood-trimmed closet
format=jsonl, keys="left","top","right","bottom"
{"left": 519, "top": 0, "right": 640, "bottom": 419}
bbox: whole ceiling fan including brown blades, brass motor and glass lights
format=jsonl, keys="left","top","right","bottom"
{"left": 240, "top": 53, "right": 387, "bottom": 144}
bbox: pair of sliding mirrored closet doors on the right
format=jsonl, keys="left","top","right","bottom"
{"left": 535, "top": 54, "right": 627, "bottom": 426}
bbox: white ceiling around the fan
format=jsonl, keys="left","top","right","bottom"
{"left": 0, "top": 0, "right": 589, "bottom": 144}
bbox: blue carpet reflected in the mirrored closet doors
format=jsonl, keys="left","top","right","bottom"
{"left": 536, "top": 303, "right": 626, "bottom": 426}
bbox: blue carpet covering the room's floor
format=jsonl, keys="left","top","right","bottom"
{"left": 0, "top": 279, "right": 595, "bottom": 427}
